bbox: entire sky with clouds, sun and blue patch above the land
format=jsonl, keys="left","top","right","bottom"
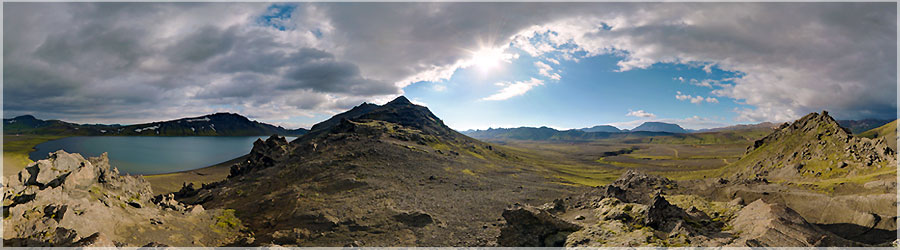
{"left": 2, "top": 3, "right": 897, "bottom": 130}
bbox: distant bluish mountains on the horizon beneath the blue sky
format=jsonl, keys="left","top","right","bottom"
{"left": 463, "top": 127, "right": 672, "bottom": 141}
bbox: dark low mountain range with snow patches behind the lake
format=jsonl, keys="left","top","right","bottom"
{"left": 3, "top": 113, "right": 308, "bottom": 136}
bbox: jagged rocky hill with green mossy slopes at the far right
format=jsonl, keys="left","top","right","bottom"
{"left": 729, "top": 111, "right": 897, "bottom": 182}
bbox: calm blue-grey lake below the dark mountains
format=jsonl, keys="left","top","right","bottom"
{"left": 28, "top": 136, "right": 296, "bottom": 175}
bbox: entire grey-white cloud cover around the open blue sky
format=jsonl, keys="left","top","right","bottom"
{"left": 3, "top": 3, "right": 897, "bottom": 125}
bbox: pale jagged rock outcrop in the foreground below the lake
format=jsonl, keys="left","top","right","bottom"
{"left": 3, "top": 151, "right": 246, "bottom": 247}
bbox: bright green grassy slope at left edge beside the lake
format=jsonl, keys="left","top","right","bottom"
{"left": 3, "top": 135, "right": 65, "bottom": 175}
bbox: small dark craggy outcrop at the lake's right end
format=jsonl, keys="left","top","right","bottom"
{"left": 228, "top": 135, "right": 289, "bottom": 178}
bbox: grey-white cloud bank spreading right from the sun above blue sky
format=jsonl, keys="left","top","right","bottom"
{"left": 513, "top": 3, "right": 897, "bottom": 121}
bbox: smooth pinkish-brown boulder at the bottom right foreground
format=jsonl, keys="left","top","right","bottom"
{"left": 731, "top": 199, "right": 860, "bottom": 247}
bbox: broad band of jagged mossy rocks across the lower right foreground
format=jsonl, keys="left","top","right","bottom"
{"left": 497, "top": 171, "right": 864, "bottom": 247}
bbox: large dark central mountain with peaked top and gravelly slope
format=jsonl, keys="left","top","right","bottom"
{"left": 175, "top": 97, "right": 575, "bottom": 246}
